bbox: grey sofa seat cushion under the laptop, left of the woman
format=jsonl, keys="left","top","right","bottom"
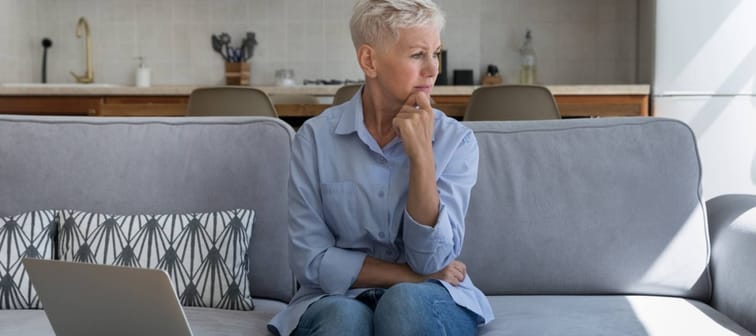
{"left": 0, "top": 298, "right": 286, "bottom": 336}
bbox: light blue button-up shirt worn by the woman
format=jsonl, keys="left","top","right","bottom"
{"left": 269, "top": 90, "right": 493, "bottom": 335}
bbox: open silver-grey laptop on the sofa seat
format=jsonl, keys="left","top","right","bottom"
{"left": 23, "top": 258, "right": 192, "bottom": 336}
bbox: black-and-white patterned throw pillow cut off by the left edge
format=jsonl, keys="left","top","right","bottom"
{"left": 0, "top": 210, "right": 58, "bottom": 309}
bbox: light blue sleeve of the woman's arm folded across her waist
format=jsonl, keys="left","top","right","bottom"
{"left": 289, "top": 126, "right": 365, "bottom": 294}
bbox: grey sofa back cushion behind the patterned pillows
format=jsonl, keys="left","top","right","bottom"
{"left": 0, "top": 116, "right": 294, "bottom": 301}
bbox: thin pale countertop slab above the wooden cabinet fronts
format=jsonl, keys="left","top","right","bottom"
{"left": 0, "top": 83, "right": 651, "bottom": 97}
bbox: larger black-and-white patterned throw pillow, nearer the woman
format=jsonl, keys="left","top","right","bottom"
{"left": 58, "top": 209, "right": 255, "bottom": 310}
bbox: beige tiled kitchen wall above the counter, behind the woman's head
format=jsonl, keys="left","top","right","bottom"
{"left": 0, "top": 0, "right": 639, "bottom": 85}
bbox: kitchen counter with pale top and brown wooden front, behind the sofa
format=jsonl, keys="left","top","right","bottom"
{"left": 0, "top": 84, "right": 651, "bottom": 119}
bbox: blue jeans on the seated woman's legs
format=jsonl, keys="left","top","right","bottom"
{"left": 292, "top": 282, "right": 478, "bottom": 336}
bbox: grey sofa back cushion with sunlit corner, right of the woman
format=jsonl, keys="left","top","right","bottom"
{"left": 461, "top": 118, "right": 710, "bottom": 300}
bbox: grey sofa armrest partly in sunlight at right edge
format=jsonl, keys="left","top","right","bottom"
{"left": 706, "top": 195, "right": 756, "bottom": 332}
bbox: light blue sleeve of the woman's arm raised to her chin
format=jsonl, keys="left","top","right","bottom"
{"left": 403, "top": 130, "right": 479, "bottom": 274}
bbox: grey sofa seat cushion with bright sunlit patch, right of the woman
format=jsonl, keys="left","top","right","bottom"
{"left": 480, "top": 295, "right": 753, "bottom": 336}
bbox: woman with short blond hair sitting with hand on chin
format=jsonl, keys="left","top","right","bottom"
{"left": 269, "top": 0, "right": 493, "bottom": 335}
